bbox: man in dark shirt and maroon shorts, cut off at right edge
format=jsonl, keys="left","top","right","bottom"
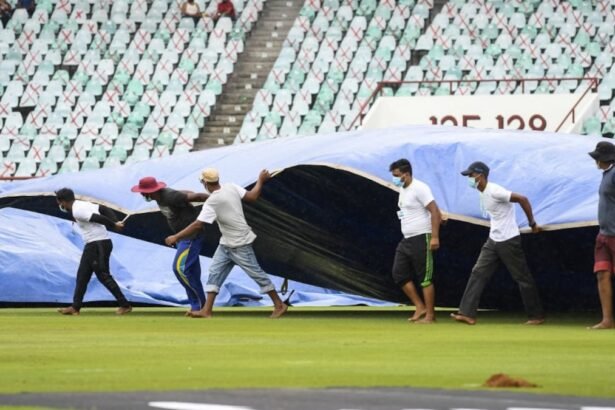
{"left": 589, "top": 141, "right": 615, "bottom": 329}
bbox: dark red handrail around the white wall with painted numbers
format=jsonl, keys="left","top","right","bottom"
{"left": 347, "top": 77, "right": 600, "bottom": 131}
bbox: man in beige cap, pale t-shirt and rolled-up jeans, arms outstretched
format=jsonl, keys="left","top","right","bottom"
{"left": 165, "top": 168, "right": 288, "bottom": 319}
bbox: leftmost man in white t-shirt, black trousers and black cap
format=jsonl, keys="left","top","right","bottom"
{"left": 56, "top": 188, "right": 132, "bottom": 315}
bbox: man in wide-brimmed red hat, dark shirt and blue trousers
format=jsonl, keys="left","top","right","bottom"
{"left": 131, "top": 177, "right": 208, "bottom": 316}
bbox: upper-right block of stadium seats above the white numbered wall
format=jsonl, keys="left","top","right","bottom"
{"left": 410, "top": 0, "right": 615, "bottom": 137}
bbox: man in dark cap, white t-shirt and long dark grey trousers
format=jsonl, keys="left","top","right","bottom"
{"left": 451, "top": 161, "right": 544, "bottom": 325}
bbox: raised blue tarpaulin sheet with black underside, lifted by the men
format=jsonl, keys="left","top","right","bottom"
{"left": 0, "top": 126, "right": 600, "bottom": 306}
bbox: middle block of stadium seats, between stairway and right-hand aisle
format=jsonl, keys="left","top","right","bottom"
{"left": 236, "top": 0, "right": 433, "bottom": 142}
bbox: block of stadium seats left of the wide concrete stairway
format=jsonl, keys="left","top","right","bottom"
{"left": 0, "top": 0, "right": 264, "bottom": 177}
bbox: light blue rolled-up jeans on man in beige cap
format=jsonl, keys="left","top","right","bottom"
{"left": 205, "top": 244, "right": 275, "bottom": 293}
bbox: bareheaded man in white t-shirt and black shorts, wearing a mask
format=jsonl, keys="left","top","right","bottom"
{"left": 389, "top": 159, "right": 441, "bottom": 323}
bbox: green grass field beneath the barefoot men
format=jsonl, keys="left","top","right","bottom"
{"left": 0, "top": 308, "right": 615, "bottom": 397}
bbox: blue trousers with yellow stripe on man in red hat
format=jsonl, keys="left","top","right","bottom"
{"left": 173, "top": 236, "right": 205, "bottom": 311}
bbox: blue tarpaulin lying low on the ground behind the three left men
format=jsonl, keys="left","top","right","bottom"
{"left": 0, "top": 208, "right": 386, "bottom": 306}
